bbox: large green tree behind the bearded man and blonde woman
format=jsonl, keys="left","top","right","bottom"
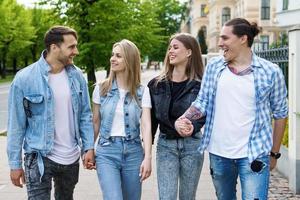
{"left": 44, "top": 0, "right": 162, "bottom": 87}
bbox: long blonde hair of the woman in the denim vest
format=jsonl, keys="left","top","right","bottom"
{"left": 100, "top": 39, "right": 141, "bottom": 98}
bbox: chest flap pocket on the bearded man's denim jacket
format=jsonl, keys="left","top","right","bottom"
{"left": 23, "top": 94, "right": 44, "bottom": 115}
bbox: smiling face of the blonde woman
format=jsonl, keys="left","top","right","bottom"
{"left": 110, "top": 45, "right": 125, "bottom": 73}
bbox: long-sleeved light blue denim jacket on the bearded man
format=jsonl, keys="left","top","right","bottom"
{"left": 7, "top": 52, "right": 94, "bottom": 177}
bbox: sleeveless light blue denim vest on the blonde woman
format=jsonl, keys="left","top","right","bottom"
{"left": 100, "top": 80, "right": 144, "bottom": 140}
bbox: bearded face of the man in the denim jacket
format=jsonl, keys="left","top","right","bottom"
{"left": 53, "top": 34, "right": 79, "bottom": 66}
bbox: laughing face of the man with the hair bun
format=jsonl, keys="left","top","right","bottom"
{"left": 218, "top": 26, "right": 248, "bottom": 62}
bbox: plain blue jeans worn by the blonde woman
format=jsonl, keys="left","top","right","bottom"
{"left": 96, "top": 137, "right": 144, "bottom": 200}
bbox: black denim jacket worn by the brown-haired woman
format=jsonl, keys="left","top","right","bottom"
{"left": 148, "top": 78, "right": 205, "bottom": 141}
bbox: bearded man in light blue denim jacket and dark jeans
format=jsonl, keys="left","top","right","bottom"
{"left": 7, "top": 26, "right": 94, "bottom": 200}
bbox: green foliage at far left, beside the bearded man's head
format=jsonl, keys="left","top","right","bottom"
{"left": 0, "top": 0, "right": 60, "bottom": 80}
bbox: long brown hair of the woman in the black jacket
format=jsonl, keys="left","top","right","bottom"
{"left": 157, "top": 33, "right": 204, "bottom": 82}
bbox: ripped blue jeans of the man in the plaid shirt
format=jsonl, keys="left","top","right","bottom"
{"left": 209, "top": 153, "right": 270, "bottom": 200}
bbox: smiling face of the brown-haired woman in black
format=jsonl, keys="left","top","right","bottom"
{"left": 168, "top": 39, "right": 191, "bottom": 66}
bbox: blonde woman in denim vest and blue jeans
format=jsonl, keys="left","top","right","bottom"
{"left": 93, "top": 40, "right": 152, "bottom": 200}
